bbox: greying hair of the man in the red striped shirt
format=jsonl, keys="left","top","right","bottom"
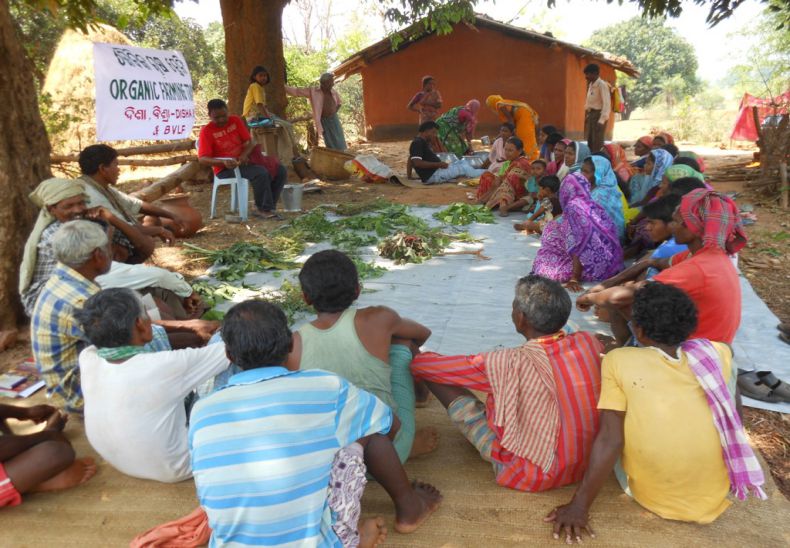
{"left": 514, "top": 274, "right": 572, "bottom": 334}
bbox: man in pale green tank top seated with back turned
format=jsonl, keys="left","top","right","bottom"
{"left": 287, "top": 250, "right": 437, "bottom": 462}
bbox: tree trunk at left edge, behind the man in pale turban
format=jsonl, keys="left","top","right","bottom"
{"left": 0, "top": 2, "right": 52, "bottom": 329}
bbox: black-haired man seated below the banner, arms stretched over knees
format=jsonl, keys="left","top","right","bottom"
{"left": 79, "top": 145, "right": 181, "bottom": 263}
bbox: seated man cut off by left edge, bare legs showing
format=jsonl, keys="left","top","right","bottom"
{"left": 0, "top": 404, "right": 96, "bottom": 508}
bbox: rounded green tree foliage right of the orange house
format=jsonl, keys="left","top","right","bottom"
{"left": 585, "top": 17, "right": 700, "bottom": 108}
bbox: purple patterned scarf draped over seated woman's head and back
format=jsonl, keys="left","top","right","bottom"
{"left": 560, "top": 173, "right": 620, "bottom": 256}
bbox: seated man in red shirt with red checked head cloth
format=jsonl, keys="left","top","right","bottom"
{"left": 576, "top": 189, "right": 746, "bottom": 345}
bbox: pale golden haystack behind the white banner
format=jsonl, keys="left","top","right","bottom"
{"left": 42, "top": 25, "right": 133, "bottom": 154}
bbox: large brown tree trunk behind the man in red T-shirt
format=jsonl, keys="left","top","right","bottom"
{"left": 219, "top": 0, "right": 290, "bottom": 116}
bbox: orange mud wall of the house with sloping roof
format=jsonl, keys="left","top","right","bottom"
{"left": 361, "top": 25, "right": 614, "bottom": 140}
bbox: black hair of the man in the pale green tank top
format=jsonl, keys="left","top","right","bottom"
{"left": 299, "top": 249, "right": 359, "bottom": 312}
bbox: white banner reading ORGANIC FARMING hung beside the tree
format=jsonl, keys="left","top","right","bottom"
{"left": 93, "top": 43, "right": 195, "bottom": 141}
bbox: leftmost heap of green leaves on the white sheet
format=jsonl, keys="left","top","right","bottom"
{"left": 184, "top": 242, "right": 299, "bottom": 282}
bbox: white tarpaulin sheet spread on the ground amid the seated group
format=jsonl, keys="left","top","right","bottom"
{"left": 210, "top": 208, "right": 790, "bottom": 413}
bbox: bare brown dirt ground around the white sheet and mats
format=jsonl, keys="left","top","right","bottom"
{"left": 0, "top": 138, "right": 790, "bottom": 499}
